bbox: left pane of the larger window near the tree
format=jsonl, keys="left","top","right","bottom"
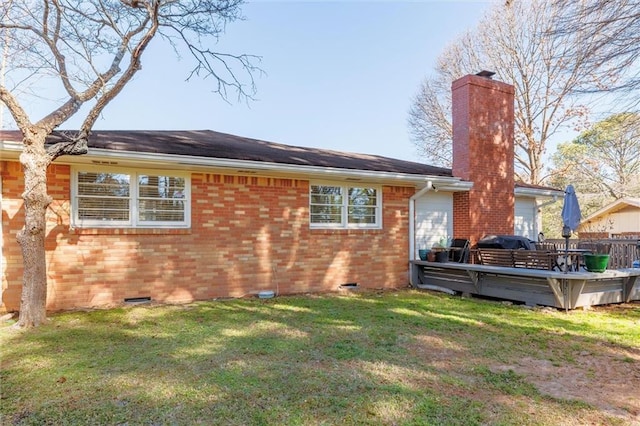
{"left": 78, "top": 172, "right": 130, "bottom": 221}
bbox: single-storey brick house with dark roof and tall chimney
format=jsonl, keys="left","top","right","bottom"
{"left": 0, "top": 76, "right": 562, "bottom": 311}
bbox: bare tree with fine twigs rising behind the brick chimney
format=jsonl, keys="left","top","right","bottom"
{"left": 408, "top": 0, "right": 598, "bottom": 184}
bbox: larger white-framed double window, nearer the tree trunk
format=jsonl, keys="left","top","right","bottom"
{"left": 71, "top": 166, "right": 191, "bottom": 228}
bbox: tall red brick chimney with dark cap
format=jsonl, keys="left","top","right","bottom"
{"left": 451, "top": 71, "right": 515, "bottom": 244}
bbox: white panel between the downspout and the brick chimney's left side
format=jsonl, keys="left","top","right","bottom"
{"left": 415, "top": 191, "right": 453, "bottom": 256}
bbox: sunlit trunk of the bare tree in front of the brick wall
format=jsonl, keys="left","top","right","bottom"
{"left": 17, "top": 133, "right": 51, "bottom": 327}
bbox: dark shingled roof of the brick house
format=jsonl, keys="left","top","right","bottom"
{"left": 0, "top": 130, "right": 452, "bottom": 177}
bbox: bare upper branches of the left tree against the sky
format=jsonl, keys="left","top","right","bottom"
{"left": 0, "top": 0, "right": 261, "bottom": 135}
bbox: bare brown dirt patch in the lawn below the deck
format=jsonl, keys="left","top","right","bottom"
{"left": 408, "top": 304, "right": 640, "bottom": 426}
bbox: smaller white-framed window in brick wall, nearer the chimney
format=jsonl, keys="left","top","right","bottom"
{"left": 309, "top": 183, "right": 382, "bottom": 229}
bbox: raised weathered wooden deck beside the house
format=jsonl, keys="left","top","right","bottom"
{"left": 410, "top": 260, "right": 640, "bottom": 309}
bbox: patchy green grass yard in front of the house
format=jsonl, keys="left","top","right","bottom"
{"left": 0, "top": 290, "right": 640, "bottom": 426}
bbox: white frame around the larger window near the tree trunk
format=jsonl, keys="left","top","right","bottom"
{"left": 71, "top": 166, "right": 191, "bottom": 229}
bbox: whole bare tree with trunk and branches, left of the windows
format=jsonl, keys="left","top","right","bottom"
{"left": 0, "top": 0, "right": 259, "bottom": 327}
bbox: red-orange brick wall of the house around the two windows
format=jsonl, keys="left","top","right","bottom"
{"left": 2, "top": 162, "right": 415, "bottom": 311}
